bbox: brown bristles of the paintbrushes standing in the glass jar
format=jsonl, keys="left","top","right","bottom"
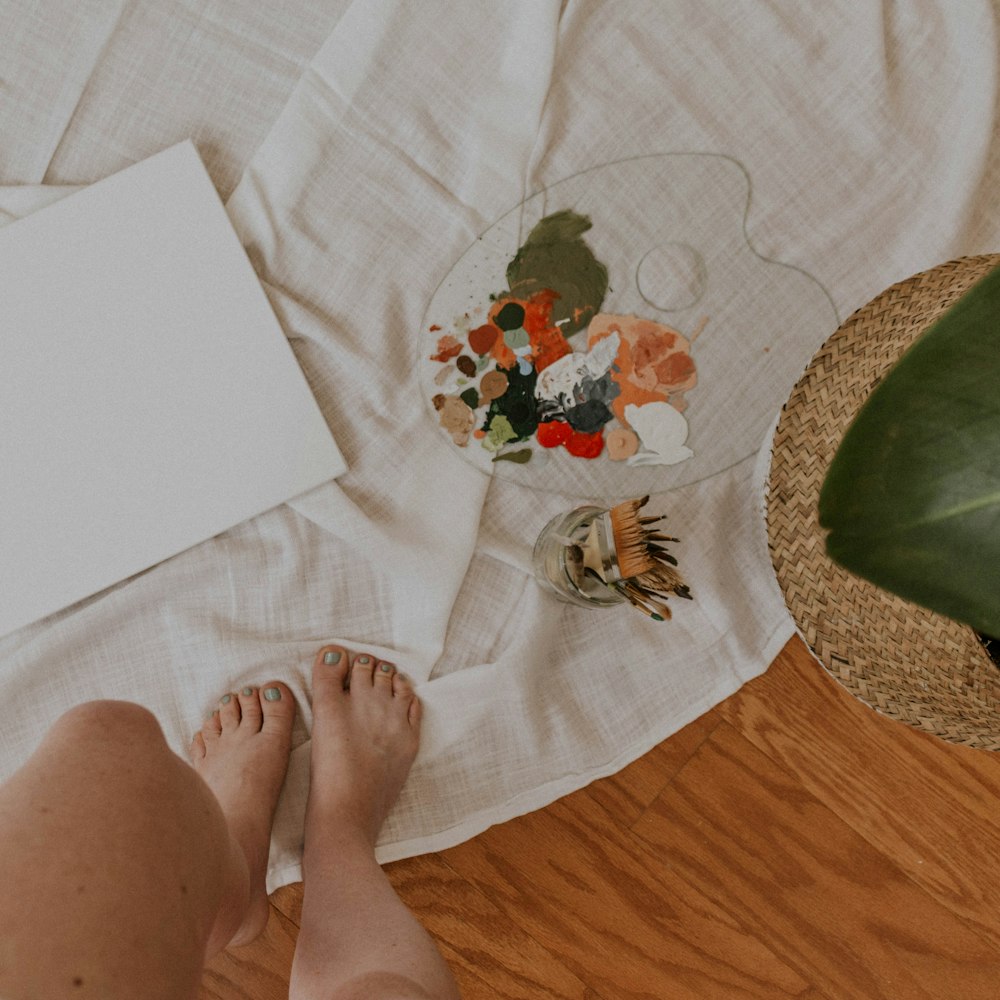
{"left": 610, "top": 496, "right": 691, "bottom": 619}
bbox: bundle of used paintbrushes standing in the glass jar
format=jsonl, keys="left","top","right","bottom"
{"left": 583, "top": 496, "right": 691, "bottom": 621}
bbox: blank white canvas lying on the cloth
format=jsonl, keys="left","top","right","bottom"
{"left": 0, "top": 142, "right": 345, "bottom": 635}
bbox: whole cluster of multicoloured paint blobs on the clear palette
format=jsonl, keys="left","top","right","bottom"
{"left": 430, "top": 211, "right": 705, "bottom": 465}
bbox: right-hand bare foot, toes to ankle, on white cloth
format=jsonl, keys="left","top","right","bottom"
{"left": 306, "top": 646, "right": 420, "bottom": 849}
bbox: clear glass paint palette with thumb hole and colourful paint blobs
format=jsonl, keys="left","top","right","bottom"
{"left": 420, "top": 154, "right": 838, "bottom": 497}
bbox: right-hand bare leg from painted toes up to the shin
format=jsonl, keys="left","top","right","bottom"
{"left": 290, "top": 646, "right": 458, "bottom": 1000}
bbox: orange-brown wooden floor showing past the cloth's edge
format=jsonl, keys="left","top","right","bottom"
{"left": 201, "top": 640, "right": 1000, "bottom": 1000}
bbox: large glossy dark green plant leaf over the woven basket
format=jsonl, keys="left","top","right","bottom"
{"left": 819, "top": 268, "right": 1000, "bottom": 635}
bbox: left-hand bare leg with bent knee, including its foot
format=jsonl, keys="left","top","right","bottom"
{"left": 0, "top": 683, "right": 295, "bottom": 1000}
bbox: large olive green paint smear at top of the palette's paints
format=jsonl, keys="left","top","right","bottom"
{"left": 507, "top": 209, "right": 608, "bottom": 337}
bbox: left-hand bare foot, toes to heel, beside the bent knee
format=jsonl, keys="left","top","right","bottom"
{"left": 189, "top": 681, "right": 295, "bottom": 951}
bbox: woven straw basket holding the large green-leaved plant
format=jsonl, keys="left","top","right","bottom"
{"left": 765, "top": 254, "right": 1000, "bottom": 750}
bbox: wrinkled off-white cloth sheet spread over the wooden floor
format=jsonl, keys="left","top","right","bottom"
{"left": 0, "top": 0, "right": 1000, "bottom": 889}
